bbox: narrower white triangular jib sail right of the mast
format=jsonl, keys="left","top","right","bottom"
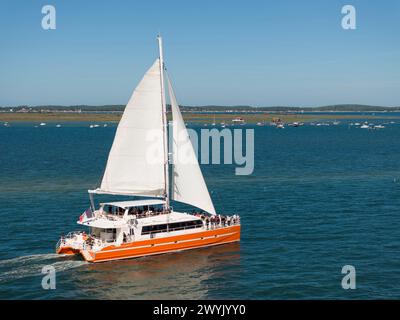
{"left": 167, "top": 77, "right": 215, "bottom": 214}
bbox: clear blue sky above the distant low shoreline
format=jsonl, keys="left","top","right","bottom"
{"left": 0, "top": 0, "right": 400, "bottom": 106}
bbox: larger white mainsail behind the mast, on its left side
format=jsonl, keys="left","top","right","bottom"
{"left": 96, "top": 59, "right": 165, "bottom": 196}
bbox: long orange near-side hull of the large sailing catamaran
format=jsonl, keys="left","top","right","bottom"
{"left": 66, "top": 225, "right": 240, "bottom": 262}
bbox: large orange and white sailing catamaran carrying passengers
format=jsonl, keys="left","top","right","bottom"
{"left": 56, "top": 37, "right": 240, "bottom": 262}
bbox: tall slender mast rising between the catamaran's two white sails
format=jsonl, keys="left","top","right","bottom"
{"left": 157, "top": 35, "right": 169, "bottom": 210}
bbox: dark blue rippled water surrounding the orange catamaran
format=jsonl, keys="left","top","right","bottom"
{"left": 0, "top": 118, "right": 400, "bottom": 299}
